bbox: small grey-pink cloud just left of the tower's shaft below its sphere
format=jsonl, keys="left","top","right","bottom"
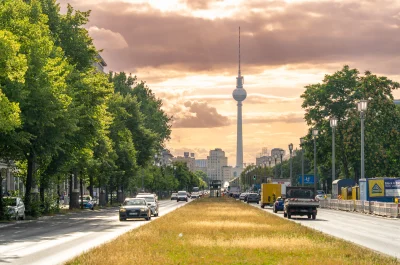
{"left": 172, "top": 101, "right": 230, "bottom": 128}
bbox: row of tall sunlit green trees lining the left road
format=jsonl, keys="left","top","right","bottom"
{"left": 0, "top": 0, "right": 184, "bottom": 218}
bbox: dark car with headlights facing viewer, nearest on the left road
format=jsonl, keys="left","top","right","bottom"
{"left": 119, "top": 198, "right": 151, "bottom": 222}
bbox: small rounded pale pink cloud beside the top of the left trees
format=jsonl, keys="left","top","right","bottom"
{"left": 88, "top": 26, "right": 128, "bottom": 50}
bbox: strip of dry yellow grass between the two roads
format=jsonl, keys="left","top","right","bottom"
{"left": 68, "top": 198, "right": 400, "bottom": 265}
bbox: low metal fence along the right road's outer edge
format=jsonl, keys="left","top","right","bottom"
{"left": 319, "top": 199, "right": 400, "bottom": 218}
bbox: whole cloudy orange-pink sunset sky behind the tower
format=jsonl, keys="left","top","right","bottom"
{"left": 58, "top": 0, "right": 400, "bottom": 166}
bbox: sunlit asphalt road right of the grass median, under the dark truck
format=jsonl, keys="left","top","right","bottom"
{"left": 248, "top": 201, "right": 400, "bottom": 258}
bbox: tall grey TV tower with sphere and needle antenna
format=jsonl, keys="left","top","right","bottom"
{"left": 232, "top": 27, "right": 247, "bottom": 168}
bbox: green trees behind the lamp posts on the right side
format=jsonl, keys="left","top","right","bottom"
{"left": 241, "top": 65, "right": 400, "bottom": 190}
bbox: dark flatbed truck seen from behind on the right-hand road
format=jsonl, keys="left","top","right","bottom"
{"left": 283, "top": 187, "right": 319, "bottom": 220}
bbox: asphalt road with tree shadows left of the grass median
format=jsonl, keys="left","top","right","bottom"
{"left": 0, "top": 198, "right": 186, "bottom": 265}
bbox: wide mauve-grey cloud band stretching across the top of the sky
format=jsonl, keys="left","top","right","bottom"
{"left": 56, "top": 0, "right": 400, "bottom": 74}
